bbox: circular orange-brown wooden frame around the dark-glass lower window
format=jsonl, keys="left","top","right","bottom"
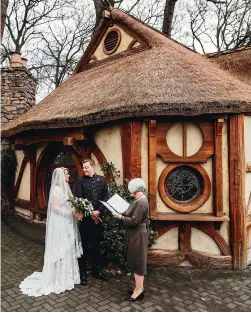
{"left": 158, "top": 163, "right": 211, "bottom": 213}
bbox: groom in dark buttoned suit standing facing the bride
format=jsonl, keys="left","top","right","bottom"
{"left": 76, "top": 159, "right": 109, "bottom": 285}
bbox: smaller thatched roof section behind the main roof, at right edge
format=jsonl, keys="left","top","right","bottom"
{"left": 206, "top": 46, "right": 251, "bottom": 85}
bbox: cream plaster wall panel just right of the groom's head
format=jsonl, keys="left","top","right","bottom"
{"left": 94, "top": 126, "right": 123, "bottom": 184}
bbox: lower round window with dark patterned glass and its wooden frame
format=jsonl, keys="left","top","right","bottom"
{"left": 159, "top": 164, "right": 211, "bottom": 212}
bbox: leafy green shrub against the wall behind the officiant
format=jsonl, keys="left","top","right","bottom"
{"left": 101, "top": 163, "right": 157, "bottom": 271}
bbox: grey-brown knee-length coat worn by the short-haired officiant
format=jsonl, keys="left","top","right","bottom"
{"left": 122, "top": 198, "right": 149, "bottom": 276}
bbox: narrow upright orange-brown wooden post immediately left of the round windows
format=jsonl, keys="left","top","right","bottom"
{"left": 148, "top": 120, "right": 157, "bottom": 217}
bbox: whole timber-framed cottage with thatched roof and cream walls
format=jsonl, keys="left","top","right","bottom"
{"left": 2, "top": 9, "right": 251, "bottom": 269}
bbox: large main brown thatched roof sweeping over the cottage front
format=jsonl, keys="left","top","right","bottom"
{"left": 3, "top": 9, "right": 251, "bottom": 136}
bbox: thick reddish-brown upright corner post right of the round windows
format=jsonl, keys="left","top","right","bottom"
{"left": 229, "top": 114, "right": 247, "bottom": 270}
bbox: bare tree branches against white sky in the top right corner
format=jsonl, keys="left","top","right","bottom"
{"left": 183, "top": 0, "right": 251, "bottom": 53}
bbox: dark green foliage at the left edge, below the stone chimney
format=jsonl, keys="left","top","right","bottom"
{"left": 1, "top": 149, "right": 17, "bottom": 215}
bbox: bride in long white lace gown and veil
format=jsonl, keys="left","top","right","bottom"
{"left": 19, "top": 168, "right": 83, "bottom": 297}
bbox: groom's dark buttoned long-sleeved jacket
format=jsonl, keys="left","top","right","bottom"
{"left": 76, "top": 174, "right": 109, "bottom": 216}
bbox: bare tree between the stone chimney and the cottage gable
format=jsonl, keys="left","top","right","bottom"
{"left": 30, "top": 6, "right": 94, "bottom": 98}
